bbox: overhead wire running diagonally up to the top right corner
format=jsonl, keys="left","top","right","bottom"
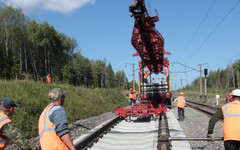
{"left": 188, "top": 0, "right": 240, "bottom": 61}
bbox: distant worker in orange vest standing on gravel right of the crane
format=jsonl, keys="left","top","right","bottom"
{"left": 174, "top": 92, "right": 186, "bottom": 121}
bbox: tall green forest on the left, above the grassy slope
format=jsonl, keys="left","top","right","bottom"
{"left": 0, "top": 6, "right": 136, "bottom": 89}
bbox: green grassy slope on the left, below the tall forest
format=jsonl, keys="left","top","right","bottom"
{"left": 0, "top": 80, "right": 128, "bottom": 138}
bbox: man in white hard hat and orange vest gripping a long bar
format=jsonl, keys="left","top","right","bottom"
{"left": 207, "top": 89, "right": 240, "bottom": 150}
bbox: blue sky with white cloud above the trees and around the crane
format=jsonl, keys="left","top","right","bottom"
{"left": 0, "top": 0, "right": 240, "bottom": 89}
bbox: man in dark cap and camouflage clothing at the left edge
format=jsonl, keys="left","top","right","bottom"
{"left": 0, "top": 97, "right": 35, "bottom": 150}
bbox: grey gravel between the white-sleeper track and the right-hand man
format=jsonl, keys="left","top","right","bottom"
{"left": 172, "top": 107, "right": 224, "bottom": 150}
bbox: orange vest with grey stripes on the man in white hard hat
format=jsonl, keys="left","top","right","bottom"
{"left": 222, "top": 101, "right": 240, "bottom": 141}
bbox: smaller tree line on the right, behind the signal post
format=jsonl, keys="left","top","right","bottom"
{"left": 184, "top": 60, "right": 240, "bottom": 89}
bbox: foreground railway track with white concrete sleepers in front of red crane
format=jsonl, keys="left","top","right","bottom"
{"left": 75, "top": 117, "right": 170, "bottom": 150}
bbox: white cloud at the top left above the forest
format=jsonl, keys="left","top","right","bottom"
{"left": 5, "top": 0, "right": 95, "bottom": 14}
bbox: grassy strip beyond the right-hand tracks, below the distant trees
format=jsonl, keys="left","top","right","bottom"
{"left": 173, "top": 89, "right": 233, "bottom": 107}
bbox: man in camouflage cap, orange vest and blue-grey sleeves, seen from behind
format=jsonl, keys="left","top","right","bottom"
{"left": 38, "top": 88, "right": 75, "bottom": 150}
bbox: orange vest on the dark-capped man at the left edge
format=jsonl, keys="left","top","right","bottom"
{"left": 0, "top": 112, "right": 12, "bottom": 150}
